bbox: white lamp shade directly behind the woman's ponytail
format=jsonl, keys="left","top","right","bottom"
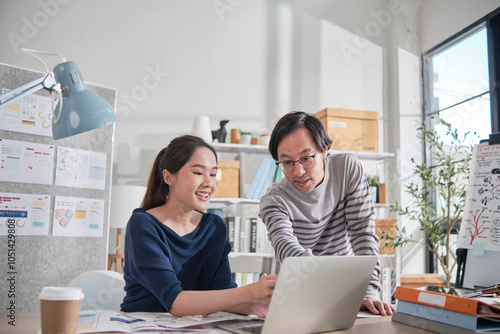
{"left": 110, "top": 184, "right": 146, "bottom": 228}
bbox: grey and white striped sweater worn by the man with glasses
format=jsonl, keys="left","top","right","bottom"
{"left": 259, "top": 154, "right": 380, "bottom": 299}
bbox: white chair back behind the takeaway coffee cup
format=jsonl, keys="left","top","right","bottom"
{"left": 69, "top": 270, "right": 125, "bottom": 311}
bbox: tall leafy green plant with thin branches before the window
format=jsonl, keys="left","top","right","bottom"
{"left": 381, "top": 120, "right": 472, "bottom": 287}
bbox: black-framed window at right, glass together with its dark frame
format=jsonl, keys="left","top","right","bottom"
{"left": 422, "top": 10, "right": 500, "bottom": 272}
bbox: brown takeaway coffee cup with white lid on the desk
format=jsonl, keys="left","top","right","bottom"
{"left": 39, "top": 286, "right": 84, "bottom": 334}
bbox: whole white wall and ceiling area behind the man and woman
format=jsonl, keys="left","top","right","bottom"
{"left": 0, "top": 0, "right": 500, "bottom": 272}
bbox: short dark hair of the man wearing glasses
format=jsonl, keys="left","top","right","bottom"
{"left": 269, "top": 111, "right": 332, "bottom": 161}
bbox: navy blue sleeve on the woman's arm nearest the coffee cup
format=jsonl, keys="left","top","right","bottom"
{"left": 125, "top": 215, "right": 182, "bottom": 311}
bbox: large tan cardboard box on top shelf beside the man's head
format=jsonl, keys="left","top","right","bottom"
{"left": 316, "top": 108, "right": 378, "bottom": 152}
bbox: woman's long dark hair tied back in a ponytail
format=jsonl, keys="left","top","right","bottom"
{"left": 141, "top": 135, "right": 217, "bottom": 210}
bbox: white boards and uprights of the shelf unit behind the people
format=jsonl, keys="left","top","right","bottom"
{"left": 211, "top": 143, "right": 401, "bottom": 288}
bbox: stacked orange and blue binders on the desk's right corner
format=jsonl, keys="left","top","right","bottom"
{"left": 392, "top": 286, "right": 500, "bottom": 334}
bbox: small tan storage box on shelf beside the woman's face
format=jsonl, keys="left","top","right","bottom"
{"left": 212, "top": 160, "right": 240, "bottom": 198}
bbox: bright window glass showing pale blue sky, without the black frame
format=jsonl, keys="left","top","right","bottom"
{"left": 424, "top": 25, "right": 491, "bottom": 143}
